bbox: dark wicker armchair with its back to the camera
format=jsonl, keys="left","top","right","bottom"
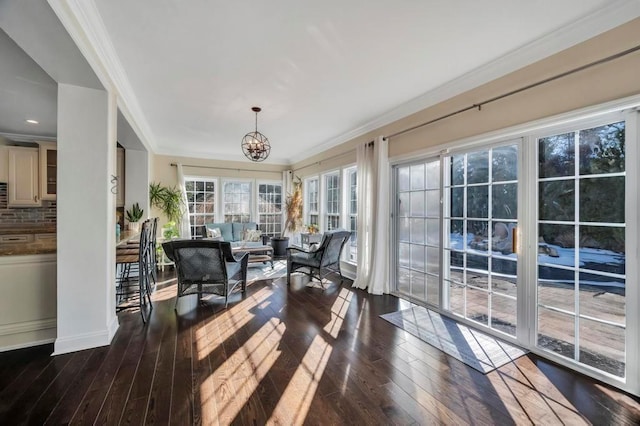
{"left": 162, "top": 240, "right": 249, "bottom": 308}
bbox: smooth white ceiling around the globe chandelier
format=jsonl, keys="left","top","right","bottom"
{"left": 0, "top": 0, "right": 640, "bottom": 164}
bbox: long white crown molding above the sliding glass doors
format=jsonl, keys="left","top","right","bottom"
{"left": 291, "top": 0, "right": 640, "bottom": 163}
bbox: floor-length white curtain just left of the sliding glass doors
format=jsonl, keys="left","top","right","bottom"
{"left": 353, "top": 137, "right": 390, "bottom": 294}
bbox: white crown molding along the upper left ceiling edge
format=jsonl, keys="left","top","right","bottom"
{"left": 47, "top": 0, "right": 155, "bottom": 152}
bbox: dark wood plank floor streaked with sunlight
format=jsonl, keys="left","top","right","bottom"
{"left": 0, "top": 271, "right": 640, "bottom": 425}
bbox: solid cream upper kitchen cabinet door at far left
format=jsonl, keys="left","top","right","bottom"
{"left": 8, "top": 146, "right": 41, "bottom": 207}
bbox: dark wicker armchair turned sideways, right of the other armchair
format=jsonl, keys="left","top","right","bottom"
{"left": 287, "top": 230, "right": 351, "bottom": 288}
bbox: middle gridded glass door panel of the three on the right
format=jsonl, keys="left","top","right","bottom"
{"left": 443, "top": 143, "right": 518, "bottom": 336}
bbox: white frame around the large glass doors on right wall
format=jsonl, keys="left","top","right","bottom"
{"left": 390, "top": 96, "right": 640, "bottom": 395}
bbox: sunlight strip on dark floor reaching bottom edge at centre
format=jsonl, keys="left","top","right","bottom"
{"left": 269, "top": 336, "right": 333, "bottom": 424}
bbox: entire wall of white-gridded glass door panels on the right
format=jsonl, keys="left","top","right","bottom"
{"left": 391, "top": 111, "right": 640, "bottom": 391}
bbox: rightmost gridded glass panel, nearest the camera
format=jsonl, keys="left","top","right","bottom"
{"left": 537, "top": 121, "right": 627, "bottom": 377}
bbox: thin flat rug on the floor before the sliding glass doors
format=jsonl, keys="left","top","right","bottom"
{"left": 380, "top": 307, "right": 527, "bottom": 374}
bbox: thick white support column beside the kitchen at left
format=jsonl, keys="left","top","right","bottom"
{"left": 54, "top": 84, "right": 118, "bottom": 355}
